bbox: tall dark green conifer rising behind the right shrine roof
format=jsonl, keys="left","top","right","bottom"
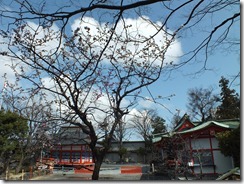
{"left": 216, "top": 77, "right": 240, "bottom": 119}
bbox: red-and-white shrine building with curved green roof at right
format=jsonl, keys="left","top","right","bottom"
{"left": 153, "top": 114, "right": 240, "bottom": 174}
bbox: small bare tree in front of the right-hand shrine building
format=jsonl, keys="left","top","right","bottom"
{"left": 157, "top": 133, "right": 211, "bottom": 180}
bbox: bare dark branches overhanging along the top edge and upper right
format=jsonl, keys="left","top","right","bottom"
{"left": 0, "top": 0, "right": 240, "bottom": 72}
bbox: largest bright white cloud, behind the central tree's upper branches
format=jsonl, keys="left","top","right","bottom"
{"left": 71, "top": 17, "right": 183, "bottom": 65}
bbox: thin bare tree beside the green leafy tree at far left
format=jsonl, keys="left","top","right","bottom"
{"left": 2, "top": 84, "right": 61, "bottom": 173}
